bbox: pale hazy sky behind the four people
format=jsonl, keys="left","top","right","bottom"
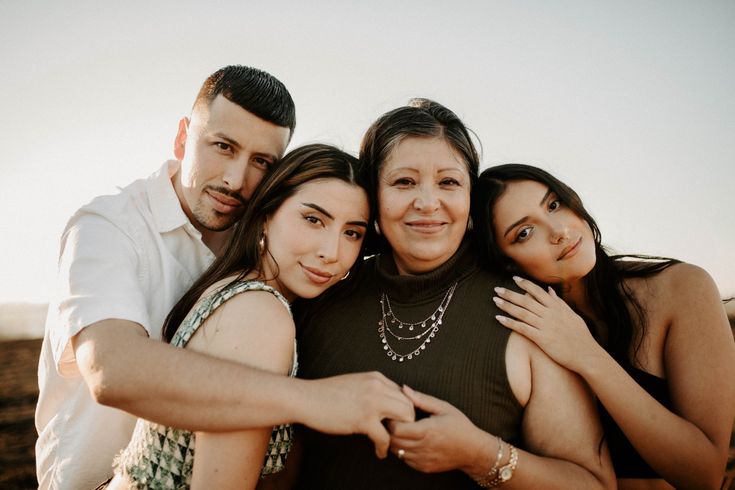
{"left": 0, "top": 0, "right": 735, "bottom": 303}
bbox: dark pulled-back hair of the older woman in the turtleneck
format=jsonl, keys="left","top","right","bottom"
{"left": 360, "top": 98, "right": 480, "bottom": 253}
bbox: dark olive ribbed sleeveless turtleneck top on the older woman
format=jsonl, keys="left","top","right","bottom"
{"left": 297, "top": 243, "right": 522, "bottom": 489}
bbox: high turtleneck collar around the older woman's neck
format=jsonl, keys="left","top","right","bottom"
{"left": 376, "top": 238, "right": 479, "bottom": 303}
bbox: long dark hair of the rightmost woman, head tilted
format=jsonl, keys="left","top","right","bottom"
{"left": 472, "top": 163, "right": 679, "bottom": 368}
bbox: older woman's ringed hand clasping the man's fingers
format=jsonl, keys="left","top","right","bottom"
{"left": 389, "top": 386, "right": 489, "bottom": 475}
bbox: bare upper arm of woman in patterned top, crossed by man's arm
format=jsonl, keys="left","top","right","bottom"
{"left": 187, "top": 291, "right": 295, "bottom": 489}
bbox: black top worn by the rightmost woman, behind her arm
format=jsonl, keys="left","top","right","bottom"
{"left": 598, "top": 368, "right": 671, "bottom": 479}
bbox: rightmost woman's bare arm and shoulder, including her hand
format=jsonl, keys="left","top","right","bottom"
{"left": 499, "top": 264, "right": 735, "bottom": 488}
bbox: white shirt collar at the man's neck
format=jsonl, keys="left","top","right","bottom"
{"left": 146, "top": 160, "right": 193, "bottom": 233}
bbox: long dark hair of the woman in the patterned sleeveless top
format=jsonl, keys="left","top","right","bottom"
{"left": 163, "top": 144, "right": 365, "bottom": 342}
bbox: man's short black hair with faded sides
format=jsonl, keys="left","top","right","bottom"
{"left": 193, "top": 65, "right": 296, "bottom": 137}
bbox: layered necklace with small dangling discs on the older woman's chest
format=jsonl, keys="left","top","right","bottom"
{"left": 378, "top": 282, "right": 457, "bottom": 362}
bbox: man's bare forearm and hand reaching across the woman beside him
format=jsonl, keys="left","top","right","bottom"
{"left": 72, "top": 319, "right": 414, "bottom": 457}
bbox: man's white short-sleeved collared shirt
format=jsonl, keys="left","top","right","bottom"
{"left": 36, "top": 161, "right": 214, "bottom": 489}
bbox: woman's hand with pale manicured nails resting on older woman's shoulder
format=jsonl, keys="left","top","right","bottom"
{"left": 493, "top": 277, "right": 602, "bottom": 373}
